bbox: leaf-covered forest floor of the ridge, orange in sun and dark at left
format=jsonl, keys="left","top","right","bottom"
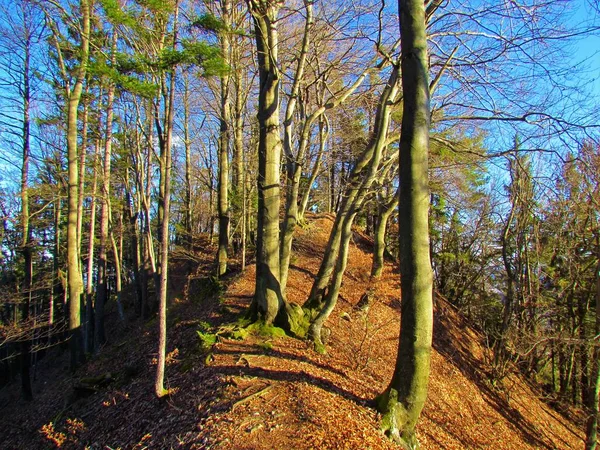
{"left": 0, "top": 216, "right": 584, "bottom": 450}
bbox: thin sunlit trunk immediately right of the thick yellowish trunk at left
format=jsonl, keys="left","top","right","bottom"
{"left": 83, "top": 138, "right": 100, "bottom": 353}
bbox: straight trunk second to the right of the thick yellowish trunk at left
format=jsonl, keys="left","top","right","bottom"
{"left": 94, "top": 35, "right": 117, "bottom": 352}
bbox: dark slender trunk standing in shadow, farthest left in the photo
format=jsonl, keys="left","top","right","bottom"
{"left": 21, "top": 29, "right": 33, "bottom": 400}
